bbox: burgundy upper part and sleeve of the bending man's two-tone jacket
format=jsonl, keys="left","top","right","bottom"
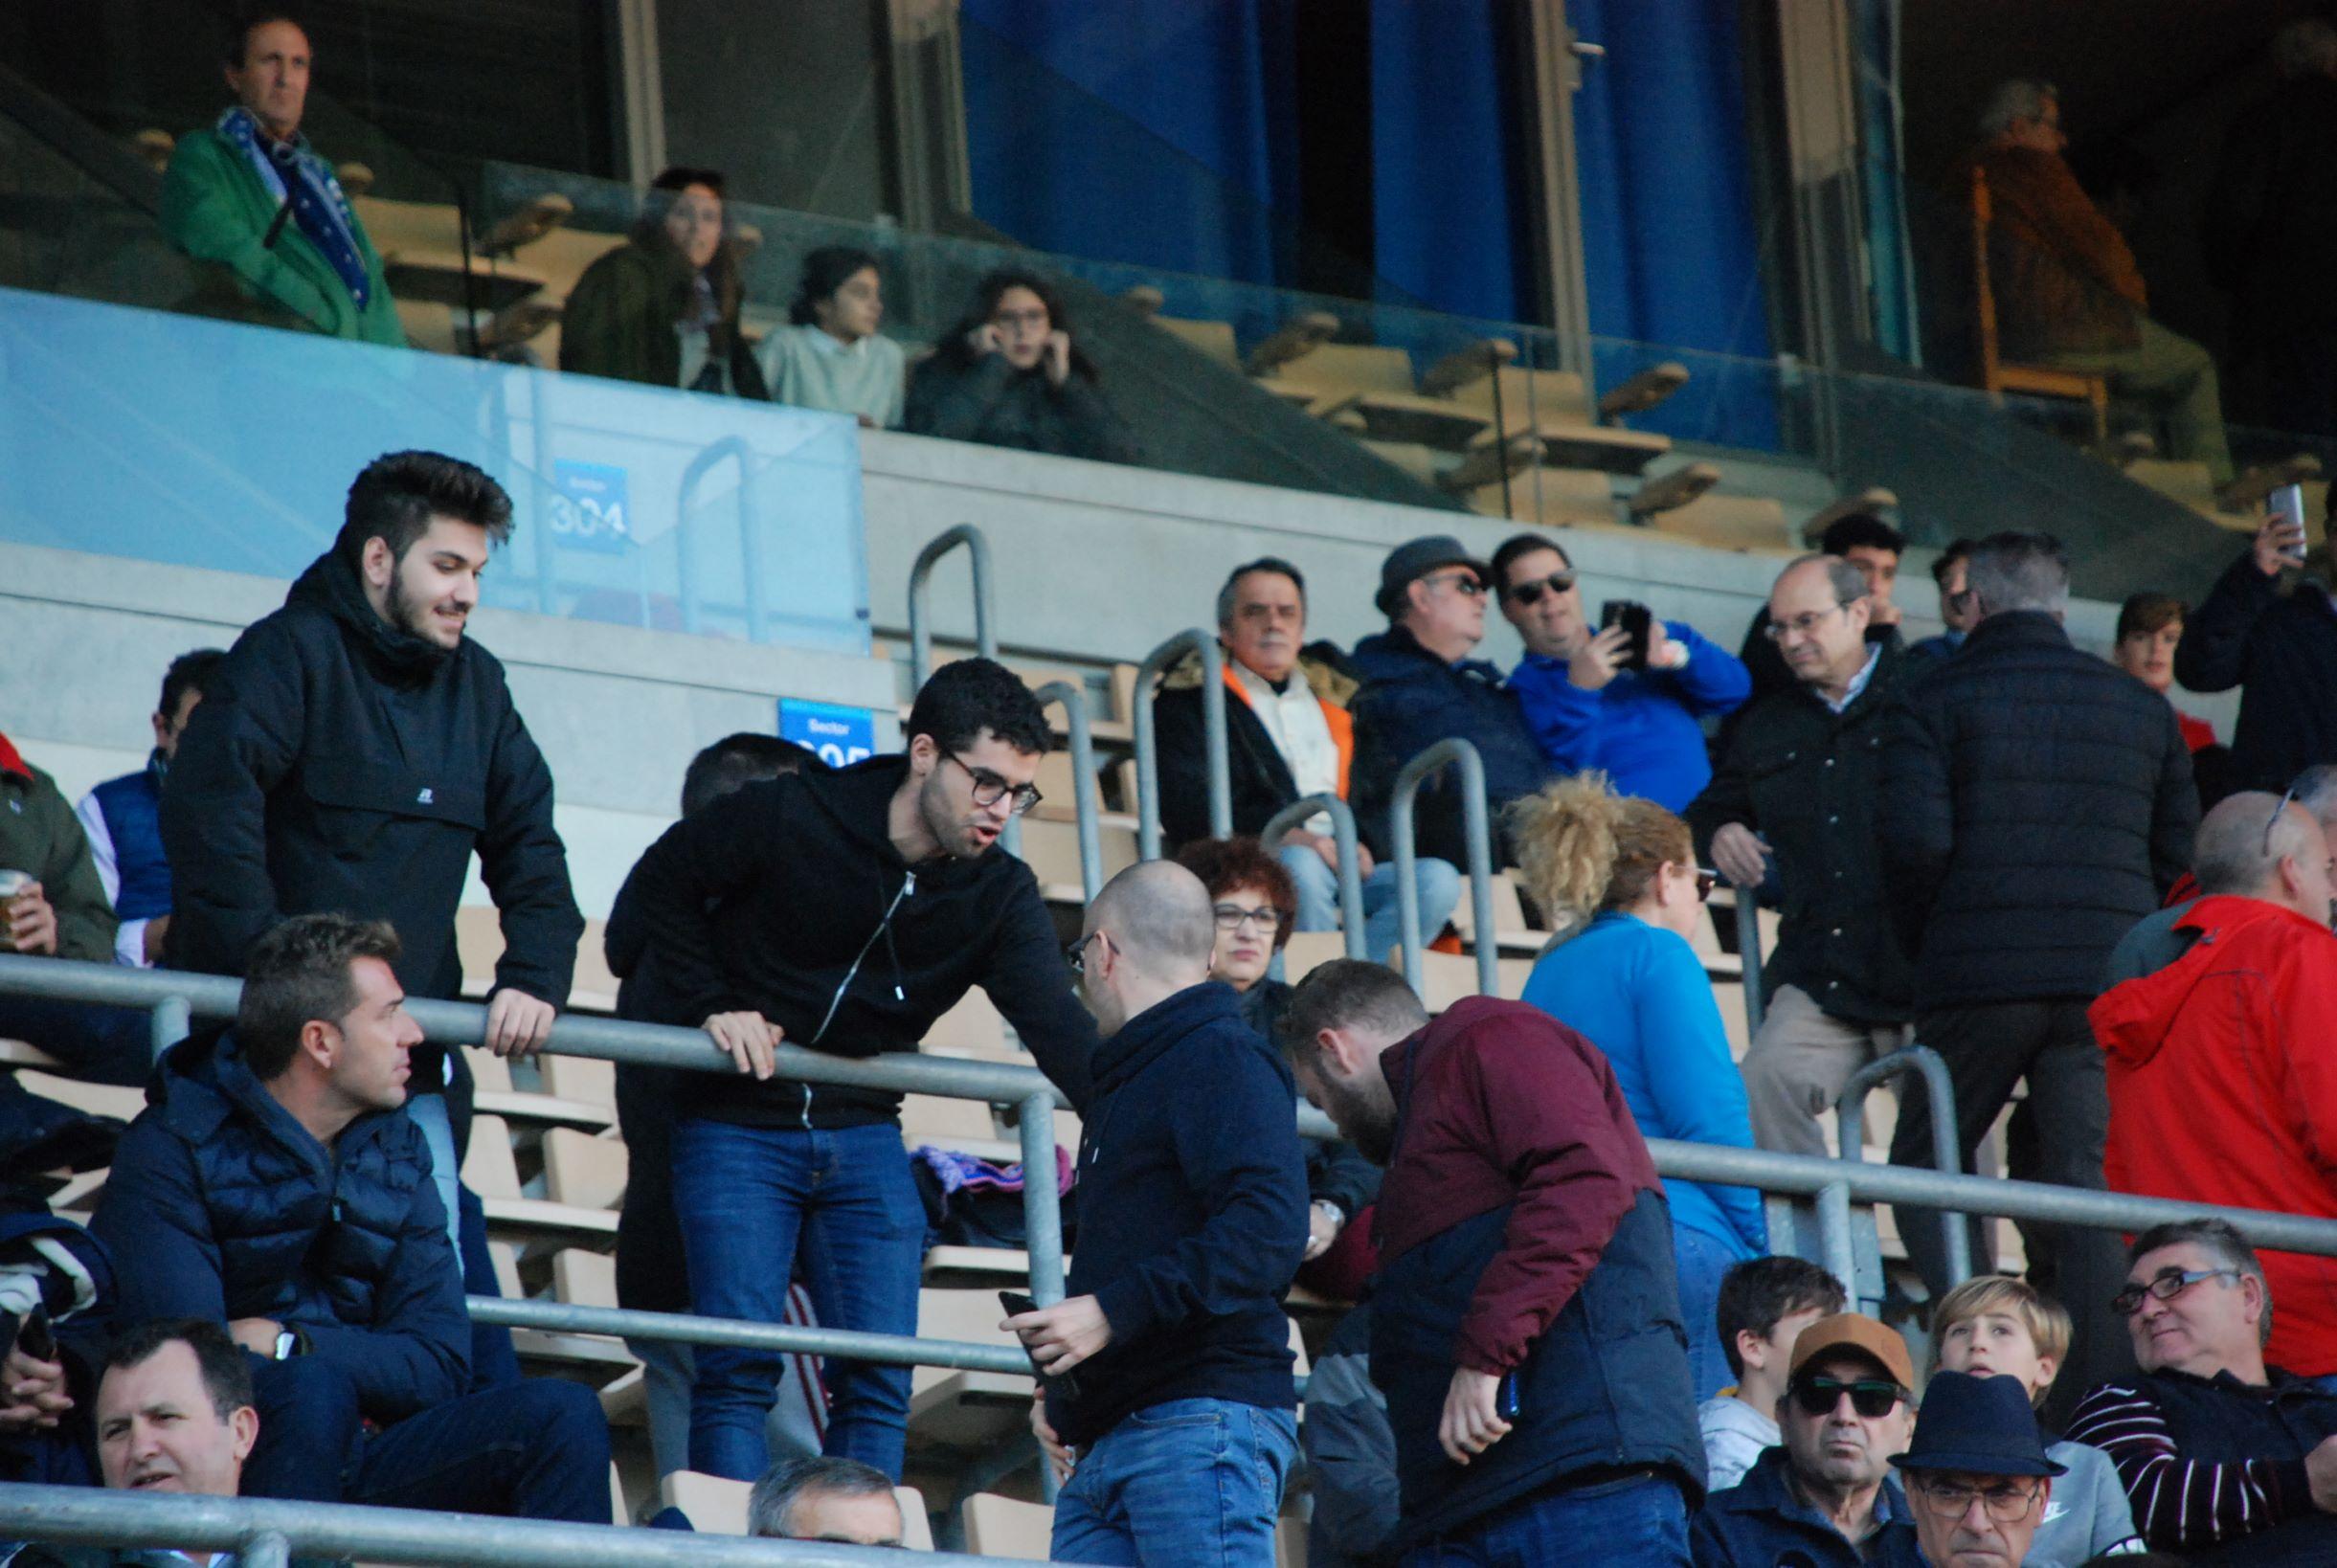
{"left": 1377, "top": 996, "right": 1659, "bottom": 1372}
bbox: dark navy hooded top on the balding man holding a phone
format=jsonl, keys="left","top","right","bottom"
{"left": 1047, "top": 981, "right": 1307, "bottom": 1442}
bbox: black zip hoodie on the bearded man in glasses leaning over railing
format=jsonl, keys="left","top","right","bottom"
{"left": 629, "top": 754, "right": 1096, "bottom": 1129}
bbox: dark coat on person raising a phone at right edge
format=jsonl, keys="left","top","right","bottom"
{"left": 2176, "top": 551, "right": 2337, "bottom": 795}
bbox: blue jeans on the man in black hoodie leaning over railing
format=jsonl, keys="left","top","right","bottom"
{"left": 673, "top": 1117, "right": 926, "bottom": 1482}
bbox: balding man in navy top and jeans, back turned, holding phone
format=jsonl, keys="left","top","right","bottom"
{"left": 1005, "top": 860, "right": 1307, "bottom": 1568}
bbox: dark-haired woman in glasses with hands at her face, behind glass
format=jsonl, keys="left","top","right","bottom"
{"left": 902, "top": 271, "right": 1135, "bottom": 462}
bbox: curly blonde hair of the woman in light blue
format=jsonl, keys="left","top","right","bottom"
{"left": 1510, "top": 769, "right": 1697, "bottom": 930}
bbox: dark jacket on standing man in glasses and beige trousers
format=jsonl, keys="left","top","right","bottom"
{"left": 1687, "top": 638, "right": 1914, "bottom": 1023}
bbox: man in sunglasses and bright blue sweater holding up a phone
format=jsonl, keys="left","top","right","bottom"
{"left": 1494, "top": 533, "right": 1753, "bottom": 811}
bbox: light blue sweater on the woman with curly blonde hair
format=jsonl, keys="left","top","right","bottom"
{"left": 1524, "top": 913, "right": 1769, "bottom": 1257}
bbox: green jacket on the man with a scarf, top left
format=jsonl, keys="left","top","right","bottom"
{"left": 161, "top": 126, "right": 407, "bottom": 348}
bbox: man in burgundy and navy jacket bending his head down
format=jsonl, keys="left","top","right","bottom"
{"left": 1283, "top": 960, "right": 1703, "bottom": 1568}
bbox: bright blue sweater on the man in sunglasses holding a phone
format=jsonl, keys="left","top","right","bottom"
{"left": 1510, "top": 621, "right": 1753, "bottom": 811}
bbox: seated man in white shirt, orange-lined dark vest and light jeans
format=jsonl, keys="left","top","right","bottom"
{"left": 1152, "top": 556, "right": 1461, "bottom": 958}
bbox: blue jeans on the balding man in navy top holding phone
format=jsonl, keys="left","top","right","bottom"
{"left": 1047, "top": 1400, "right": 1299, "bottom": 1568}
